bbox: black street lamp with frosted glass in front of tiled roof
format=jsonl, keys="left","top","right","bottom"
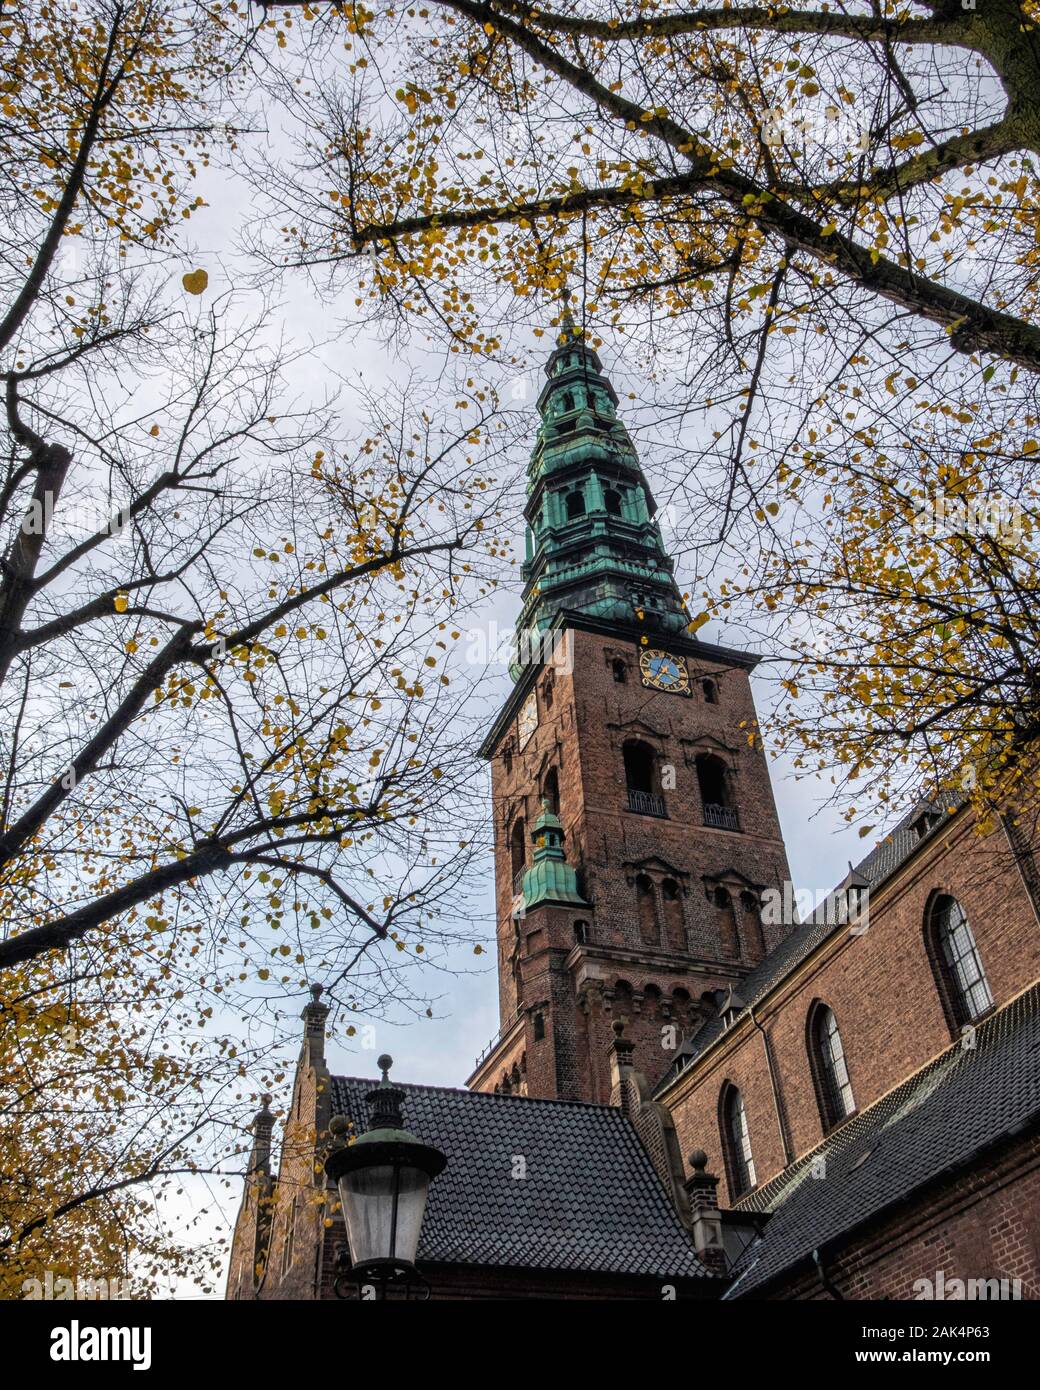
{"left": 325, "top": 1055, "right": 448, "bottom": 1298}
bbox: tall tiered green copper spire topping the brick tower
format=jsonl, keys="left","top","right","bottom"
{"left": 520, "top": 292, "right": 690, "bottom": 656}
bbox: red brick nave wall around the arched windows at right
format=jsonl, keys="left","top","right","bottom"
{"left": 667, "top": 816, "right": 1040, "bottom": 1201}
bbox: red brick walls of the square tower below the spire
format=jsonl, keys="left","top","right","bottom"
{"left": 476, "top": 631, "right": 788, "bottom": 1101}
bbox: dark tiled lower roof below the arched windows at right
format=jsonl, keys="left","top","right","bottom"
{"left": 726, "top": 986, "right": 1040, "bottom": 1298}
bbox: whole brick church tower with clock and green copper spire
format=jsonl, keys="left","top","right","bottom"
{"left": 469, "top": 310, "right": 788, "bottom": 1102}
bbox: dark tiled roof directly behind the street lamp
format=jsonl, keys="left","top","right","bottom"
{"left": 332, "top": 1076, "right": 708, "bottom": 1279}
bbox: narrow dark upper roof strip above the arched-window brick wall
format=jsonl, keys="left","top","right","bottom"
{"left": 655, "top": 798, "right": 957, "bottom": 1094}
